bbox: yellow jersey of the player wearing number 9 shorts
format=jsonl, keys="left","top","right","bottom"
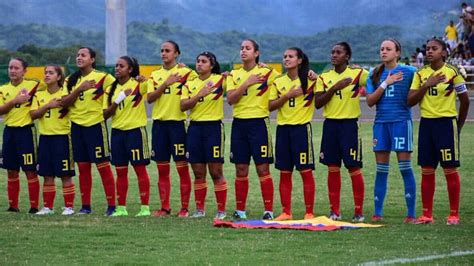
{"left": 227, "top": 65, "right": 280, "bottom": 118}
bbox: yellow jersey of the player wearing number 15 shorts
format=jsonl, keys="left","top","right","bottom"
{"left": 148, "top": 65, "right": 197, "bottom": 121}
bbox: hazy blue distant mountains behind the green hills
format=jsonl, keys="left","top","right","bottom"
{"left": 0, "top": 0, "right": 460, "bottom": 36}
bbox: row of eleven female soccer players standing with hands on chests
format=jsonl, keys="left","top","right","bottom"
{"left": 0, "top": 39, "right": 469, "bottom": 224}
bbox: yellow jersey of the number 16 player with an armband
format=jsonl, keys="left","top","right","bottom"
{"left": 411, "top": 64, "right": 467, "bottom": 118}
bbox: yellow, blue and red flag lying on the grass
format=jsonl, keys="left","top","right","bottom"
{"left": 214, "top": 216, "right": 382, "bottom": 231}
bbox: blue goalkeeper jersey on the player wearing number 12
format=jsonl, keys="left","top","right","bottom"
{"left": 366, "top": 64, "right": 416, "bottom": 123}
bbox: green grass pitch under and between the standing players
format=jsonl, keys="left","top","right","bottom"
{"left": 0, "top": 122, "right": 474, "bottom": 265}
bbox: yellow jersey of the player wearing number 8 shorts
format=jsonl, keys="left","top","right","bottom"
{"left": 270, "top": 75, "right": 316, "bottom": 125}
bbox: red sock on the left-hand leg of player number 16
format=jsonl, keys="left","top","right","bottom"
{"left": 421, "top": 166, "right": 436, "bottom": 217}
